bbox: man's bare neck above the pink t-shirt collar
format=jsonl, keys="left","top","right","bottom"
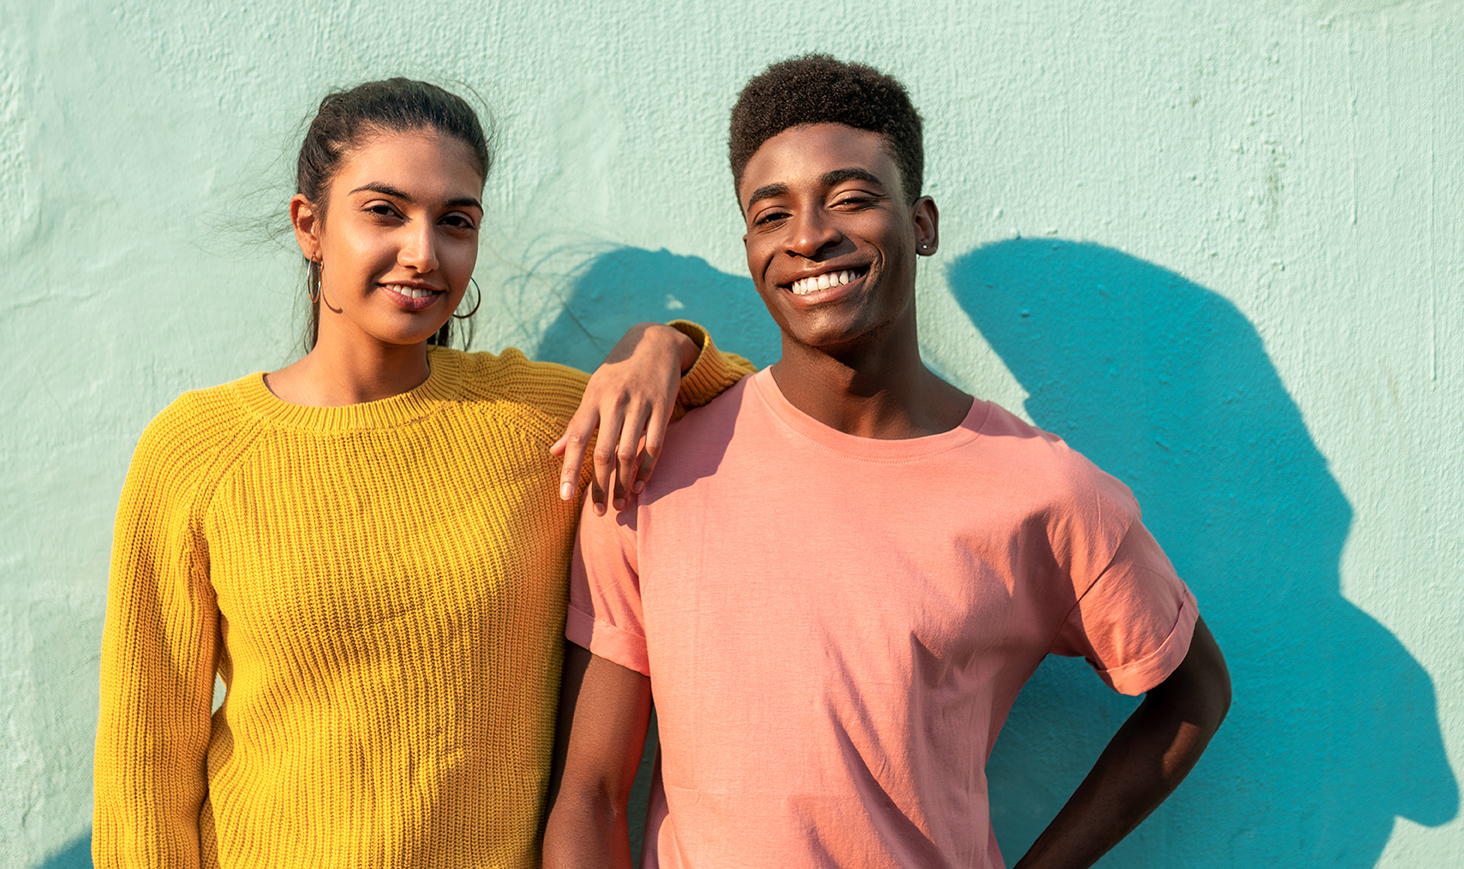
{"left": 773, "top": 323, "right": 972, "bottom": 440}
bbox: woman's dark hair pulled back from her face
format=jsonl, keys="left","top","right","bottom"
{"left": 294, "top": 78, "right": 492, "bottom": 353}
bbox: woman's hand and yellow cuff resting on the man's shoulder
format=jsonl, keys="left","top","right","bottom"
{"left": 549, "top": 320, "right": 754, "bottom": 514}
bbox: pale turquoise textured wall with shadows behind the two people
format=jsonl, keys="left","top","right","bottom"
{"left": 0, "top": 0, "right": 1464, "bottom": 868}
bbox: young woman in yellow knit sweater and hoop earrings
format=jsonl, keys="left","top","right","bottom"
{"left": 92, "top": 79, "right": 745, "bottom": 869}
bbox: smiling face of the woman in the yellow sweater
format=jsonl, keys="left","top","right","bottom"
{"left": 290, "top": 129, "right": 483, "bottom": 345}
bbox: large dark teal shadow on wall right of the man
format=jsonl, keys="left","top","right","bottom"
{"left": 947, "top": 238, "right": 1458, "bottom": 866}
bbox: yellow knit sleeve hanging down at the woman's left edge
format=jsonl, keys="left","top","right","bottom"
{"left": 92, "top": 402, "right": 221, "bottom": 869}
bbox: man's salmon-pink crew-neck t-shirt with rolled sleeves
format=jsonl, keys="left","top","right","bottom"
{"left": 567, "top": 370, "right": 1196, "bottom": 869}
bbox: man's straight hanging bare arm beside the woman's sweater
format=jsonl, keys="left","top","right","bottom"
{"left": 543, "top": 634, "right": 650, "bottom": 869}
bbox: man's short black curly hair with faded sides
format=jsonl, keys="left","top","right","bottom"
{"left": 728, "top": 54, "right": 925, "bottom": 202}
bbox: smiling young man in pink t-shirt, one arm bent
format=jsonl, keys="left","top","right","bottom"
{"left": 545, "top": 56, "right": 1230, "bottom": 869}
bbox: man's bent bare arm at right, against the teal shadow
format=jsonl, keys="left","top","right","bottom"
{"left": 1012, "top": 619, "right": 1230, "bottom": 869}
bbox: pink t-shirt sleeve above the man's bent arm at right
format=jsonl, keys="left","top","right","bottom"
{"left": 1051, "top": 521, "right": 1199, "bottom": 695}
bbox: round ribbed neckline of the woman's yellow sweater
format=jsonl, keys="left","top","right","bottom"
{"left": 237, "top": 347, "right": 463, "bottom": 432}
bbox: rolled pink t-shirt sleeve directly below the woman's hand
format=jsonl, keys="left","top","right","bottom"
{"left": 564, "top": 499, "right": 650, "bottom": 676}
